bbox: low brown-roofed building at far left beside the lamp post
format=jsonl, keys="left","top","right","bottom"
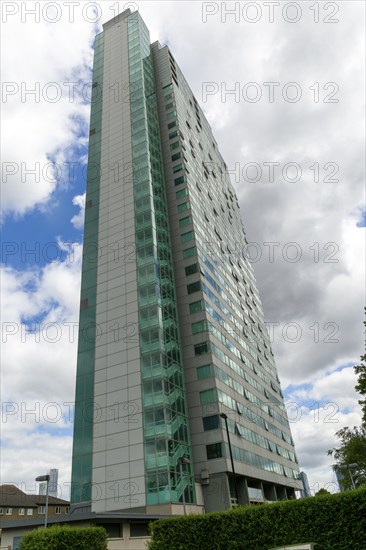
{"left": 0, "top": 485, "right": 70, "bottom": 523}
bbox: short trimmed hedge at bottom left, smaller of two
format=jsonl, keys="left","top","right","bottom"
{"left": 19, "top": 526, "right": 108, "bottom": 550}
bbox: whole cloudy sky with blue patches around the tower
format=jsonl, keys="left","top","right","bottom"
{"left": 1, "top": 1, "right": 365, "bottom": 497}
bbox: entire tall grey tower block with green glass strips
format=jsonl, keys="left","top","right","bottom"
{"left": 72, "top": 10, "right": 301, "bottom": 513}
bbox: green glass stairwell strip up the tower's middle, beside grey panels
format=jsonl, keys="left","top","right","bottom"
{"left": 128, "top": 12, "right": 195, "bottom": 505}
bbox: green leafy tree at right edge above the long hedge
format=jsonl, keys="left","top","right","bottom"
{"left": 328, "top": 426, "right": 366, "bottom": 490}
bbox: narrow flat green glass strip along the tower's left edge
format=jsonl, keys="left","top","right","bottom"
{"left": 71, "top": 33, "right": 104, "bottom": 503}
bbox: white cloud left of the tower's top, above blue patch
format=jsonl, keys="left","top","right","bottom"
{"left": 2, "top": 11, "right": 95, "bottom": 220}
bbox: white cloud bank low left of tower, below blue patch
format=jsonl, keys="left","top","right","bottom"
{"left": 1, "top": 243, "right": 81, "bottom": 496}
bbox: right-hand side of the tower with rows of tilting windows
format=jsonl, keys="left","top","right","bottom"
{"left": 151, "top": 43, "right": 301, "bottom": 511}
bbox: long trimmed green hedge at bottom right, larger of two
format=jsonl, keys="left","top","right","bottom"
{"left": 149, "top": 489, "right": 366, "bottom": 550}
